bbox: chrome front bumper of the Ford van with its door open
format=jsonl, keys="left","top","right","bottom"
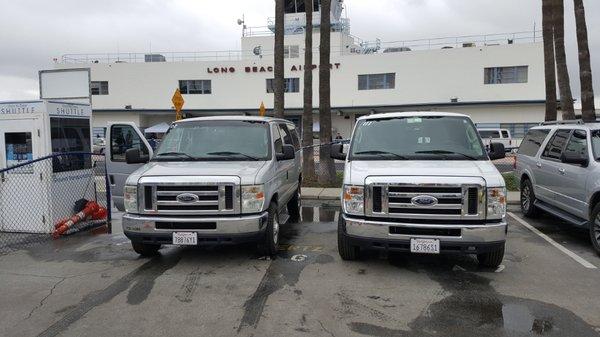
{"left": 122, "top": 212, "right": 268, "bottom": 245}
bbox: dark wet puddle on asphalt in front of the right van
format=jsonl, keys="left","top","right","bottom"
{"left": 348, "top": 256, "right": 598, "bottom": 336}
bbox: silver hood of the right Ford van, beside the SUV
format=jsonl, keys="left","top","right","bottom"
{"left": 344, "top": 160, "right": 505, "bottom": 186}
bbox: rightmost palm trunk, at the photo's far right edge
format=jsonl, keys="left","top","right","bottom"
{"left": 574, "top": 0, "right": 596, "bottom": 122}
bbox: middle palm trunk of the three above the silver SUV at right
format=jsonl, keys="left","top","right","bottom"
{"left": 553, "top": 0, "right": 575, "bottom": 119}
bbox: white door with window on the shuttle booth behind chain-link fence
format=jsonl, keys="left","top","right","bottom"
{"left": 0, "top": 119, "right": 49, "bottom": 232}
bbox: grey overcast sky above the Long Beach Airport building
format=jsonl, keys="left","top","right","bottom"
{"left": 0, "top": 0, "right": 600, "bottom": 105}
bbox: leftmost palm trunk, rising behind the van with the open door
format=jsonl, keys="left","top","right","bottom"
{"left": 273, "top": 0, "right": 285, "bottom": 118}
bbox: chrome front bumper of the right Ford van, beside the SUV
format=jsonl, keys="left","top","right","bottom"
{"left": 341, "top": 215, "right": 508, "bottom": 254}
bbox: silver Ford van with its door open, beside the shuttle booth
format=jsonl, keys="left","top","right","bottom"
{"left": 107, "top": 116, "right": 302, "bottom": 256}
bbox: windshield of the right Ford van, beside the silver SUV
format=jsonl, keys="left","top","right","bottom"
{"left": 350, "top": 116, "right": 487, "bottom": 160}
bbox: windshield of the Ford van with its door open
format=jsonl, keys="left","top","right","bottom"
{"left": 153, "top": 121, "right": 271, "bottom": 161}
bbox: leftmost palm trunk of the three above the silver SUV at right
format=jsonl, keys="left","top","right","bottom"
{"left": 542, "top": 0, "right": 557, "bottom": 122}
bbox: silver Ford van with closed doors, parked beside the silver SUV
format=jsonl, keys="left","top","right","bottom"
{"left": 331, "top": 112, "right": 507, "bottom": 267}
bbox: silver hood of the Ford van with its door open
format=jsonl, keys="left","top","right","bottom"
{"left": 127, "top": 161, "right": 266, "bottom": 185}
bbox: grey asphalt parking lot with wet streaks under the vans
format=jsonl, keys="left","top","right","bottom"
{"left": 0, "top": 205, "right": 600, "bottom": 336}
